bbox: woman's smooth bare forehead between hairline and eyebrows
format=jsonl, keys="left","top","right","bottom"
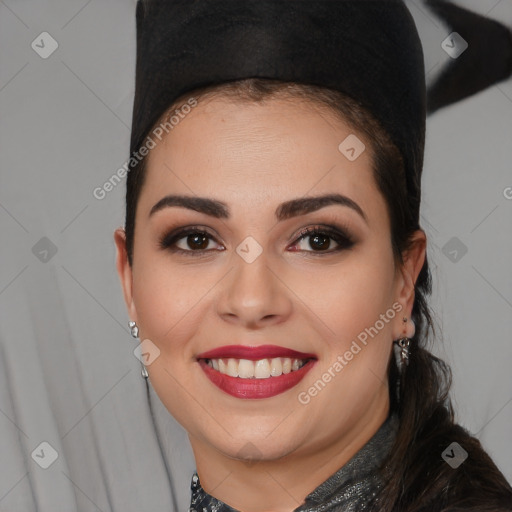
{"left": 140, "top": 97, "right": 384, "bottom": 224}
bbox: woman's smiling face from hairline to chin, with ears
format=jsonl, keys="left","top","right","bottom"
{"left": 116, "top": 97, "right": 422, "bottom": 468}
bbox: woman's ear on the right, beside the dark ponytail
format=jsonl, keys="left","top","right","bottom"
{"left": 395, "top": 229, "right": 427, "bottom": 337}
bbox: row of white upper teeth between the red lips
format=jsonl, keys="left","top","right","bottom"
{"left": 207, "top": 357, "right": 306, "bottom": 379}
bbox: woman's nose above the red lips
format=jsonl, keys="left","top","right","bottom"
{"left": 217, "top": 246, "right": 293, "bottom": 329}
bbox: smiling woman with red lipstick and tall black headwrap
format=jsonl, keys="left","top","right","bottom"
{"left": 115, "top": 0, "right": 512, "bottom": 512}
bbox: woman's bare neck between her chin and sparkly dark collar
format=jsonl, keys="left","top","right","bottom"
{"left": 190, "top": 386, "right": 389, "bottom": 512}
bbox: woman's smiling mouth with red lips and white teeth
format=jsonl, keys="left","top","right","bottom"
{"left": 197, "top": 345, "right": 316, "bottom": 399}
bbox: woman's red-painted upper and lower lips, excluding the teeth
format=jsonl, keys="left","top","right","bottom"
{"left": 197, "top": 345, "right": 317, "bottom": 399}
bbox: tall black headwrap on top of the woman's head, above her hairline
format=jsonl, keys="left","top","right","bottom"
{"left": 131, "top": 0, "right": 512, "bottom": 224}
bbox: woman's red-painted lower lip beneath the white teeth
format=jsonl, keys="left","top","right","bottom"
{"left": 199, "top": 359, "right": 316, "bottom": 399}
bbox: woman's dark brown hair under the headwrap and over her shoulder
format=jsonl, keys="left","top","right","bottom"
{"left": 125, "top": 78, "right": 512, "bottom": 512}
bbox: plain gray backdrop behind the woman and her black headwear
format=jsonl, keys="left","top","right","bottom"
{"left": 0, "top": 0, "right": 512, "bottom": 512}
